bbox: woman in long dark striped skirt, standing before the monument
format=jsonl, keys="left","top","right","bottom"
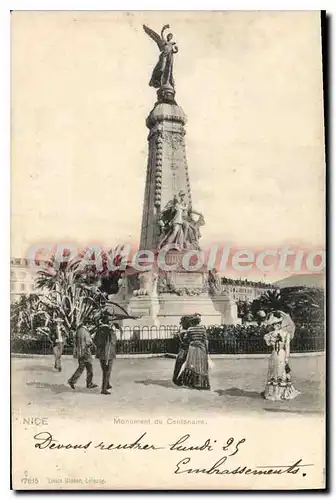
{"left": 177, "top": 314, "right": 210, "bottom": 390}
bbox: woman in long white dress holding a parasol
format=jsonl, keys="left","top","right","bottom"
{"left": 264, "top": 312, "right": 300, "bottom": 401}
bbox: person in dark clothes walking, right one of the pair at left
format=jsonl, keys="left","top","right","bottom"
{"left": 94, "top": 315, "right": 119, "bottom": 394}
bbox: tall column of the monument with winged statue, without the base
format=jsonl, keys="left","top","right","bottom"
{"left": 140, "top": 25, "right": 191, "bottom": 250}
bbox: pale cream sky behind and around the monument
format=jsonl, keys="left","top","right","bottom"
{"left": 11, "top": 11, "right": 325, "bottom": 282}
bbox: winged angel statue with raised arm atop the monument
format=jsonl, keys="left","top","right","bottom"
{"left": 143, "top": 24, "right": 178, "bottom": 89}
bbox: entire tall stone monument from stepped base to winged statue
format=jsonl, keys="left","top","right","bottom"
{"left": 119, "top": 25, "right": 236, "bottom": 326}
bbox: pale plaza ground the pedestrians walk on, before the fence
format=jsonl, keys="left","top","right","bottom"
{"left": 12, "top": 355, "right": 324, "bottom": 419}
